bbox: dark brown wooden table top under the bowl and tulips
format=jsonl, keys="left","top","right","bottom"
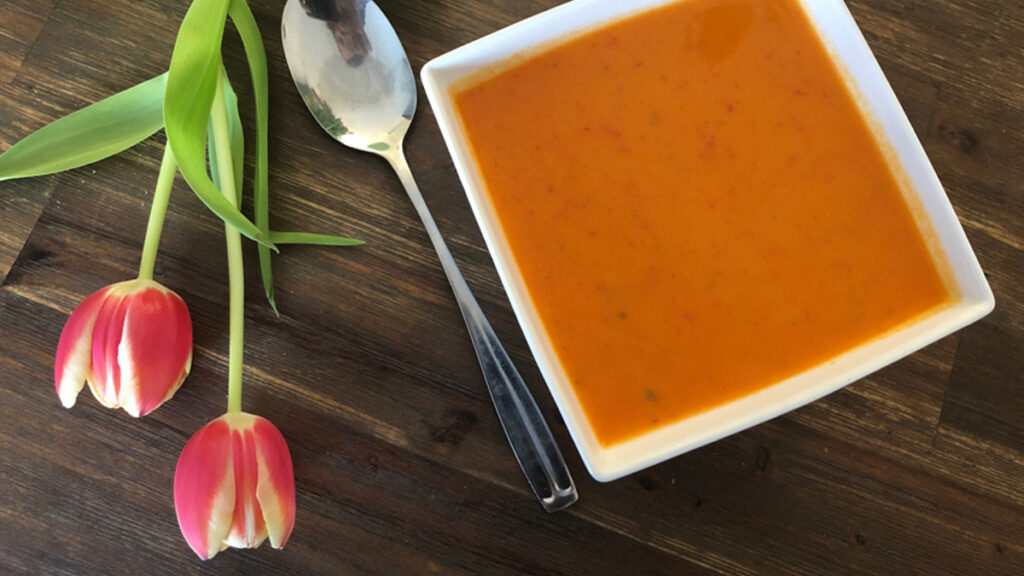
{"left": 0, "top": 0, "right": 1024, "bottom": 576}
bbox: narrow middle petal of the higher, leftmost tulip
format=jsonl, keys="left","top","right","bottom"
{"left": 86, "top": 291, "right": 128, "bottom": 408}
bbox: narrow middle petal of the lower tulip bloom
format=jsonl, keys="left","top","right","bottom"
{"left": 224, "top": 413, "right": 267, "bottom": 548}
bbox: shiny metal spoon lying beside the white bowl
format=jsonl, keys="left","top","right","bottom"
{"left": 281, "top": 0, "right": 577, "bottom": 511}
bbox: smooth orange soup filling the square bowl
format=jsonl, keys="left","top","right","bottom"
{"left": 454, "top": 0, "right": 951, "bottom": 446}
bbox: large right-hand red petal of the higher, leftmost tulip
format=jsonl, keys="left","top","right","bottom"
{"left": 118, "top": 281, "right": 191, "bottom": 417}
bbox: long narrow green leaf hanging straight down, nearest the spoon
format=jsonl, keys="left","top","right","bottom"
{"left": 227, "top": 0, "right": 278, "bottom": 314}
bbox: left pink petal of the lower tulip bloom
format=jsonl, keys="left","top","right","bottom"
{"left": 174, "top": 418, "right": 234, "bottom": 560}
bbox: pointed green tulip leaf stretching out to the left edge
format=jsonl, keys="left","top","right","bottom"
{"left": 0, "top": 74, "right": 167, "bottom": 180}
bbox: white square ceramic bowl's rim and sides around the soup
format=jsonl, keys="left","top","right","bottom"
{"left": 421, "top": 0, "right": 994, "bottom": 482}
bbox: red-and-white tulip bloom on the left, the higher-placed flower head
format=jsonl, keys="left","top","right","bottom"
{"left": 53, "top": 279, "right": 191, "bottom": 417}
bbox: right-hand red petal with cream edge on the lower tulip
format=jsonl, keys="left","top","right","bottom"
{"left": 253, "top": 418, "right": 295, "bottom": 548}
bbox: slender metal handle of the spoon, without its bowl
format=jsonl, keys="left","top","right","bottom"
{"left": 382, "top": 148, "right": 578, "bottom": 512}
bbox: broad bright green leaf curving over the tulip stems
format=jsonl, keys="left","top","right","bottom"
{"left": 164, "top": 0, "right": 272, "bottom": 247}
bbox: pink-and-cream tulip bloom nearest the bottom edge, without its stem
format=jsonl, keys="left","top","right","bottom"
{"left": 174, "top": 412, "right": 295, "bottom": 560}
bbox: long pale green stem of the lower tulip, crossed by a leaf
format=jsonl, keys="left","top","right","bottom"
{"left": 210, "top": 68, "right": 246, "bottom": 412}
